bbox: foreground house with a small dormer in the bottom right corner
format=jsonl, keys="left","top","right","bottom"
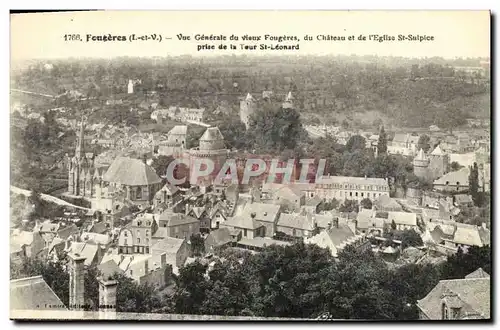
{"left": 417, "top": 271, "right": 491, "bottom": 320}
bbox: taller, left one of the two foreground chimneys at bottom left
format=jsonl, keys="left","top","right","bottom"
{"left": 68, "top": 253, "right": 85, "bottom": 310}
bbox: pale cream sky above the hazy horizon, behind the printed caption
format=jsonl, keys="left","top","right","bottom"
{"left": 11, "top": 11, "right": 490, "bottom": 61}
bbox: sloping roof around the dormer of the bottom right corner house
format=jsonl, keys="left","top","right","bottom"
{"left": 417, "top": 278, "right": 491, "bottom": 320}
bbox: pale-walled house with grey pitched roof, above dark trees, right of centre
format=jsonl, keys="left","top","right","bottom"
{"left": 276, "top": 213, "right": 316, "bottom": 238}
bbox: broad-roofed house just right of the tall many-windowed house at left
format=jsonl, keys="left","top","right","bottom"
{"left": 155, "top": 210, "right": 200, "bottom": 238}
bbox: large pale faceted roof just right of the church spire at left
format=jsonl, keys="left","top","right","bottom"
{"left": 103, "top": 157, "right": 161, "bottom": 186}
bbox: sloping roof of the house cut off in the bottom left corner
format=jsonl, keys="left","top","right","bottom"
{"left": 10, "top": 275, "right": 68, "bottom": 312}
